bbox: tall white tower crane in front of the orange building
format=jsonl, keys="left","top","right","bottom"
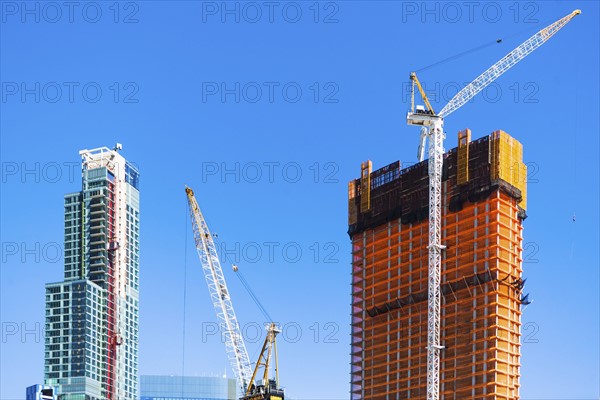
{"left": 406, "top": 10, "right": 581, "bottom": 400}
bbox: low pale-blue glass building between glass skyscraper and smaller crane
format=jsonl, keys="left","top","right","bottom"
{"left": 140, "top": 375, "right": 237, "bottom": 400}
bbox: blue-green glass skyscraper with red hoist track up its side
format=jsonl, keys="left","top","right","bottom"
{"left": 44, "top": 144, "right": 139, "bottom": 400}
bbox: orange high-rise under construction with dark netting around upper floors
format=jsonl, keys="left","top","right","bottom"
{"left": 348, "top": 129, "right": 527, "bottom": 400}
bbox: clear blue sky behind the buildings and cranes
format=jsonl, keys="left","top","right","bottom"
{"left": 0, "top": 1, "right": 600, "bottom": 400}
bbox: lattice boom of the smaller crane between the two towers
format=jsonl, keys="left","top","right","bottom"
{"left": 185, "top": 187, "right": 252, "bottom": 393}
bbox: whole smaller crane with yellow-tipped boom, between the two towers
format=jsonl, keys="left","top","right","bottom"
{"left": 185, "top": 186, "right": 284, "bottom": 400}
